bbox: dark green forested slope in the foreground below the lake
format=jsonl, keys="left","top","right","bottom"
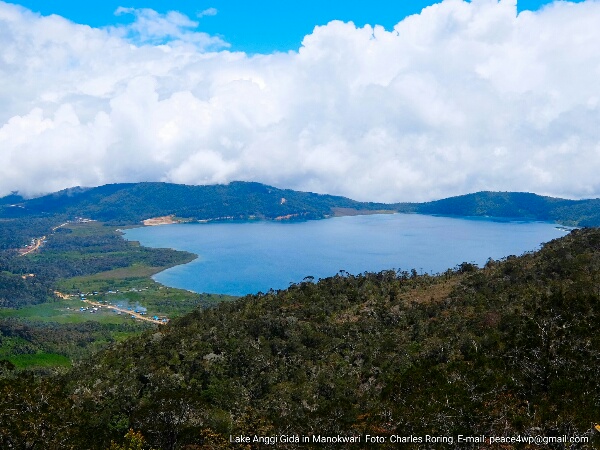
{"left": 0, "top": 229, "right": 600, "bottom": 449}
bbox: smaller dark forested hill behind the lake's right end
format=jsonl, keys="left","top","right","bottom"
{"left": 390, "top": 192, "right": 600, "bottom": 227}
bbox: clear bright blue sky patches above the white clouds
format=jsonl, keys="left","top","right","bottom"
{"left": 8, "top": 0, "right": 579, "bottom": 53}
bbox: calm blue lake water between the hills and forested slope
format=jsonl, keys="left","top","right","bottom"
{"left": 125, "top": 214, "right": 565, "bottom": 295}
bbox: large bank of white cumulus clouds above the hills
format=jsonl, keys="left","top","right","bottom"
{"left": 0, "top": 0, "right": 600, "bottom": 201}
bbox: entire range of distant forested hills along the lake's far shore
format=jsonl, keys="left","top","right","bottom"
{"left": 0, "top": 181, "right": 600, "bottom": 226}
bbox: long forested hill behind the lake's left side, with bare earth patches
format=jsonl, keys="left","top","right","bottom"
{"left": 0, "top": 182, "right": 385, "bottom": 223}
